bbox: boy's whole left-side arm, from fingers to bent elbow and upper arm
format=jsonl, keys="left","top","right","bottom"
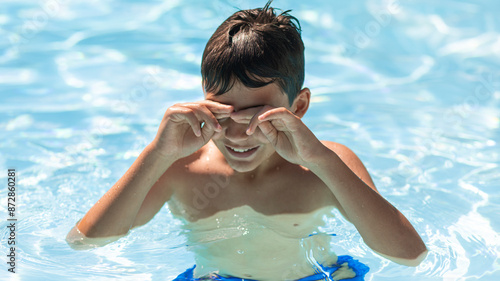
{"left": 66, "top": 101, "right": 234, "bottom": 248}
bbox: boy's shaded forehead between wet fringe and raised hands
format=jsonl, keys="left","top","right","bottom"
{"left": 205, "top": 80, "right": 288, "bottom": 111}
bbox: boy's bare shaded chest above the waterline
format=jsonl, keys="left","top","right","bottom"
{"left": 170, "top": 164, "right": 333, "bottom": 221}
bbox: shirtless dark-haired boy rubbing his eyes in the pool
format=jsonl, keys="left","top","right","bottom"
{"left": 68, "top": 2, "right": 427, "bottom": 280}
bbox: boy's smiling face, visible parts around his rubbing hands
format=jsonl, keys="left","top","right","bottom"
{"left": 205, "top": 82, "right": 290, "bottom": 172}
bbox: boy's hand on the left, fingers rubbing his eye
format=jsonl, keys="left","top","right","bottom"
{"left": 153, "top": 100, "right": 234, "bottom": 160}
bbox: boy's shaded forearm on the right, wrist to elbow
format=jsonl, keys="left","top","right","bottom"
{"left": 308, "top": 149, "right": 426, "bottom": 260}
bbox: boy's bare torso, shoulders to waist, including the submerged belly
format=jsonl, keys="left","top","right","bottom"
{"left": 165, "top": 142, "right": 342, "bottom": 280}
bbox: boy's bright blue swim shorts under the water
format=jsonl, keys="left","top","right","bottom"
{"left": 173, "top": 255, "right": 370, "bottom": 281}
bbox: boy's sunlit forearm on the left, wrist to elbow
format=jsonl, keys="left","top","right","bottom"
{"left": 77, "top": 144, "right": 175, "bottom": 237}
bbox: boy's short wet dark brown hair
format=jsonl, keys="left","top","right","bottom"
{"left": 201, "top": 1, "right": 304, "bottom": 105}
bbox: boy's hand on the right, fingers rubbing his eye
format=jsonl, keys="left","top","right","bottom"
{"left": 231, "top": 105, "right": 326, "bottom": 166}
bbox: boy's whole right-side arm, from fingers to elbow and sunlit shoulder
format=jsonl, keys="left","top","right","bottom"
{"left": 244, "top": 104, "right": 427, "bottom": 266}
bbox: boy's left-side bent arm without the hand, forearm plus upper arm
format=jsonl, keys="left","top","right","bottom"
{"left": 67, "top": 144, "right": 174, "bottom": 245}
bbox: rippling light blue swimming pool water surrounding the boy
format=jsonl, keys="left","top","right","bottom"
{"left": 0, "top": 0, "right": 500, "bottom": 281}
